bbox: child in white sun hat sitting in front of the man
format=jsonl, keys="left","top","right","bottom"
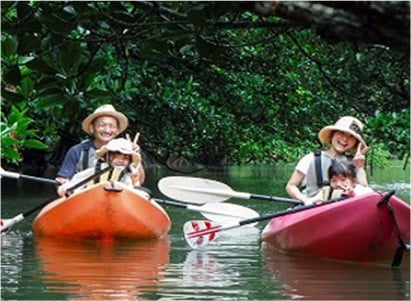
{"left": 57, "top": 138, "right": 144, "bottom": 196}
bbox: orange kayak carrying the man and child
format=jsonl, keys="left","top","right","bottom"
{"left": 33, "top": 182, "right": 171, "bottom": 240}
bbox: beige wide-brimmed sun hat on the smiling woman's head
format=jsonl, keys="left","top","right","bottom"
{"left": 318, "top": 116, "right": 367, "bottom": 145}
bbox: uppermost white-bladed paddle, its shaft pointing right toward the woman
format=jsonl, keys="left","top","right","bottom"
{"left": 158, "top": 176, "right": 303, "bottom": 205}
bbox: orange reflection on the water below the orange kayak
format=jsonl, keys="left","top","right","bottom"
{"left": 36, "top": 238, "right": 170, "bottom": 300}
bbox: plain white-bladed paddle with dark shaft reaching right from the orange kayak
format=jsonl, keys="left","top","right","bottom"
{"left": 153, "top": 198, "right": 260, "bottom": 224}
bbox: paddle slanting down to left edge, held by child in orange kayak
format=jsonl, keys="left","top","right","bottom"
{"left": 0, "top": 166, "right": 112, "bottom": 235}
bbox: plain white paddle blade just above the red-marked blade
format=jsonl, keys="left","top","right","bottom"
{"left": 201, "top": 203, "right": 260, "bottom": 226}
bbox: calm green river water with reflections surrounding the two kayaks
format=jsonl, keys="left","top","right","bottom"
{"left": 1, "top": 164, "right": 410, "bottom": 301}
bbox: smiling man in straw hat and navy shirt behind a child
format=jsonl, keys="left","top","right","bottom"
{"left": 56, "top": 104, "right": 143, "bottom": 183}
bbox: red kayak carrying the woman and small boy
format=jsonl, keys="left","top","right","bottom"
{"left": 262, "top": 192, "right": 411, "bottom": 265}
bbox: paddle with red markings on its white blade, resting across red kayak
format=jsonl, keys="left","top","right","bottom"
{"left": 183, "top": 198, "right": 348, "bottom": 249}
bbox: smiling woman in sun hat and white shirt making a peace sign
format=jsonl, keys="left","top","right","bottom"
{"left": 286, "top": 116, "right": 368, "bottom": 204}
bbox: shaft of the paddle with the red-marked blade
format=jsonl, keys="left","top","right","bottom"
{"left": 188, "top": 198, "right": 342, "bottom": 238}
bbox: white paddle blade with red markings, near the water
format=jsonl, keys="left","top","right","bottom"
{"left": 183, "top": 220, "right": 221, "bottom": 249}
